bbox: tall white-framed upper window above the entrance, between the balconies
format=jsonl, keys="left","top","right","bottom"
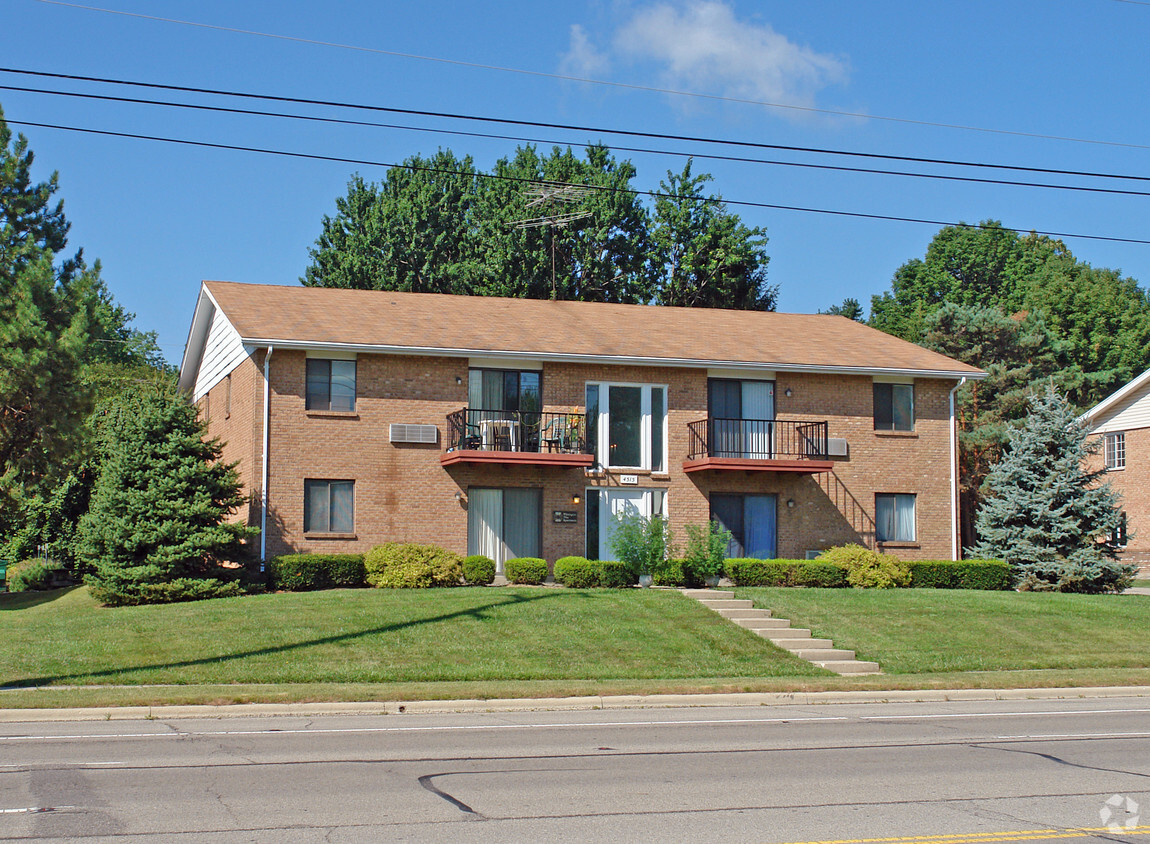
{"left": 587, "top": 384, "right": 667, "bottom": 471}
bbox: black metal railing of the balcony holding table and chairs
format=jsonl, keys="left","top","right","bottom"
{"left": 446, "top": 407, "right": 591, "bottom": 454}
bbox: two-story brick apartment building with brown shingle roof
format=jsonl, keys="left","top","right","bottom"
{"left": 179, "top": 282, "right": 984, "bottom": 567}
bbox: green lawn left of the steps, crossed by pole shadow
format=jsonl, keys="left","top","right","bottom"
{"left": 0, "top": 588, "right": 825, "bottom": 706}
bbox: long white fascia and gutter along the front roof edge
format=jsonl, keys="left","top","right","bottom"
{"left": 235, "top": 337, "right": 987, "bottom": 381}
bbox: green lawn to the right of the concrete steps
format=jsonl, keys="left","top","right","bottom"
{"left": 736, "top": 589, "right": 1150, "bottom": 676}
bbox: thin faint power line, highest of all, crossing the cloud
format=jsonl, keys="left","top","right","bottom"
{"left": 37, "top": 0, "right": 1150, "bottom": 149}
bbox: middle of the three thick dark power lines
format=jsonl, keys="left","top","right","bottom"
{"left": 0, "top": 85, "right": 1150, "bottom": 197}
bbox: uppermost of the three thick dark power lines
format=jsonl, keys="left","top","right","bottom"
{"left": 0, "top": 66, "right": 1150, "bottom": 182}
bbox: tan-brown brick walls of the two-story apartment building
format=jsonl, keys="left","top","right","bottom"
{"left": 200, "top": 350, "right": 953, "bottom": 561}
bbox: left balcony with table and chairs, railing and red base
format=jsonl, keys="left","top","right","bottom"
{"left": 439, "top": 407, "right": 595, "bottom": 468}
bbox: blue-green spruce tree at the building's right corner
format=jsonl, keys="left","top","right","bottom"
{"left": 969, "top": 385, "right": 1134, "bottom": 592}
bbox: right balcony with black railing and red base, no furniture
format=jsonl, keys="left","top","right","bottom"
{"left": 683, "top": 419, "right": 834, "bottom": 475}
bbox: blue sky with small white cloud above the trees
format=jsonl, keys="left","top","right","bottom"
{"left": 0, "top": 0, "right": 1150, "bottom": 362}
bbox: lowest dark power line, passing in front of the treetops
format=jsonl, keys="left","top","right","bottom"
{"left": 7, "top": 120, "right": 1150, "bottom": 245}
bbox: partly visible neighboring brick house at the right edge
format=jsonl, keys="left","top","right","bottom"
{"left": 1082, "top": 370, "right": 1150, "bottom": 571}
